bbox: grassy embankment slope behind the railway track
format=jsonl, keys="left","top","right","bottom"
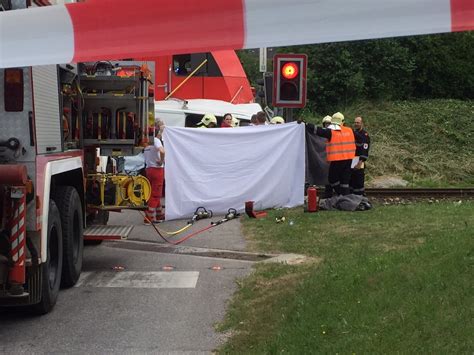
{"left": 306, "top": 99, "right": 474, "bottom": 187}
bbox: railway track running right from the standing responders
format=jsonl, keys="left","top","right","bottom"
{"left": 365, "top": 188, "right": 474, "bottom": 198}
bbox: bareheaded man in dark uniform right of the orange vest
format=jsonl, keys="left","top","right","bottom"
{"left": 350, "top": 117, "right": 370, "bottom": 195}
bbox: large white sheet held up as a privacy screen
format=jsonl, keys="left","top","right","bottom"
{"left": 163, "top": 123, "right": 305, "bottom": 220}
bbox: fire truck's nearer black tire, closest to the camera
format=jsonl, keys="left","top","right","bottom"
{"left": 33, "top": 200, "right": 63, "bottom": 314}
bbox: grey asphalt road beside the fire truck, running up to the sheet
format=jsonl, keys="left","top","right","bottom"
{"left": 0, "top": 212, "right": 253, "bottom": 354}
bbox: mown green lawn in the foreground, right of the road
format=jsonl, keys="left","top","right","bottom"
{"left": 220, "top": 201, "right": 474, "bottom": 354}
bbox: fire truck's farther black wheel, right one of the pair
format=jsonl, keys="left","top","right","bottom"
{"left": 53, "top": 186, "right": 84, "bottom": 287}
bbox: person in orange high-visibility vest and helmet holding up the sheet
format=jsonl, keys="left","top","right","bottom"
{"left": 306, "top": 112, "right": 355, "bottom": 197}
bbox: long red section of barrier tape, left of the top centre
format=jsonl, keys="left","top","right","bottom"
{"left": 66, "top": 0, "right": 244, "bottom": 62}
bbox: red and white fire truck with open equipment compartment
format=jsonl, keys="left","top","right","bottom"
{"left": 0, "top": 56, "right": 153, "bottom": 313}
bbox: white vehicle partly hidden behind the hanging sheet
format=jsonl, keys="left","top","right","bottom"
{"left": 155, "top": 99, "right": 263, "bottom": 127}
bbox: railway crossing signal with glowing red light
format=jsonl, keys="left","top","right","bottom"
{"left": 273, "top": 54, "right": 308, "bottom": 107}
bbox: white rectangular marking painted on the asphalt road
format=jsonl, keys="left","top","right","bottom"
{"left": 75, "top": 271, "right": 199, "bottom": 288}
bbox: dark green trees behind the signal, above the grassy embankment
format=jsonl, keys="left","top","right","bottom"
{"left": 239, "top": 32, "right": 474, "bottom": 113}
